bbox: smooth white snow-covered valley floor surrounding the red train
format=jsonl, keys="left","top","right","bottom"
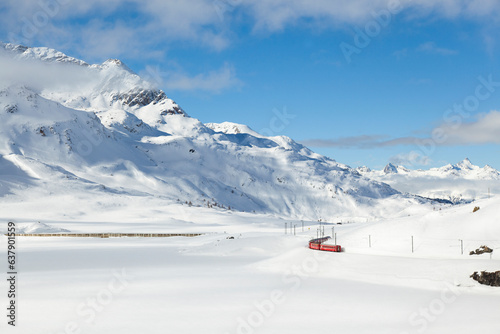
{"left": 0, "top": 199, "right": 500, "bottom": 334}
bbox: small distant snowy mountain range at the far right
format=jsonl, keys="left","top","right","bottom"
{"left": 356, "top": 158, "right": 500, "bottom": 202}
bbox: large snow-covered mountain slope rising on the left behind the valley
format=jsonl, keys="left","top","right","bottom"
{"left": 0, "top": 44, "right": 442, "bottom": 220}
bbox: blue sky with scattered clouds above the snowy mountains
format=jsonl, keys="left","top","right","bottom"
{"left": 0, "top": 0, "right": 500, "bottom": 169}
